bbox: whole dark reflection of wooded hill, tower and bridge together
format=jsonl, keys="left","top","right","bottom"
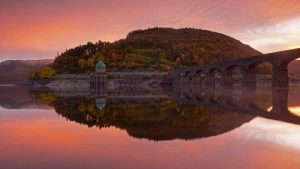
{"left": 25, "top": 84, "right": 300, "bottom": 141}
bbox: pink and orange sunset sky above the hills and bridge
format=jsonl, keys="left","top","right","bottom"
{"left": 0, "top": 0, "right": 300, "bottom": 61}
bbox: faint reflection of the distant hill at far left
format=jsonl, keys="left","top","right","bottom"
{"left": 0, "top": 86, "right": 51, "bottom": 109}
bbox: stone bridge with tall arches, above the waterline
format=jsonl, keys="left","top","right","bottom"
{"left": 168, "top": 48, "right": 300, "bottom": 86}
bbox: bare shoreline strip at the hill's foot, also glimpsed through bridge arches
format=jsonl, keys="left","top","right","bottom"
{"left": 0, "top": 72, "right": 300, "bottom": 91}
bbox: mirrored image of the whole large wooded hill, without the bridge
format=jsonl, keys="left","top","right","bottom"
{"left": 53, "top": 97, "right": 253, "bottom": 140}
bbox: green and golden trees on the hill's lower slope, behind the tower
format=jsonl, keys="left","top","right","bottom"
{"left": 53, "top": 40, "right": 192, "bottom": 73}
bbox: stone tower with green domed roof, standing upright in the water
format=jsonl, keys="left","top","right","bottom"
{"left": 90, "top": 61, "right": 107, "bottom": 94}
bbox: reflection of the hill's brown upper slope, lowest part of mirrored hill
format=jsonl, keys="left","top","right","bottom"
{"left": 126, "top": 109, "right": 252, "bottom": 140}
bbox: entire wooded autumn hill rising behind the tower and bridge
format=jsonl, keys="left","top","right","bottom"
{"left": 53, "top": 28, "right": 261, "bottom": 73}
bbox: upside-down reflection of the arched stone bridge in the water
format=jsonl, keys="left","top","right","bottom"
{"left": 169, "top": 88, "right": 300, "bottom": 124}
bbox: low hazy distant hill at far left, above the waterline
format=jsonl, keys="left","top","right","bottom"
{"left": 0, "top": 59, "right": 53, "bottom": 84}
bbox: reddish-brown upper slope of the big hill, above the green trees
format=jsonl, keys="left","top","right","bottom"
{"left": 121, "top": 28, "right": 261, "bottom": 64}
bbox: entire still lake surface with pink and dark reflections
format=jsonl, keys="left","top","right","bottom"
{"left": 0, "top": 86, "right": 300, "bottom": 169}
